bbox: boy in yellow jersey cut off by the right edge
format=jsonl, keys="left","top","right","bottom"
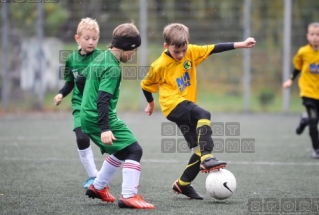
{"left": 283, "top": 22, "right": 319, "bottom": 158}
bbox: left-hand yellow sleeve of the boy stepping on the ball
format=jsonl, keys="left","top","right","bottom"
{"left": 141, "top": 65, "right": 161, "bottom": 93}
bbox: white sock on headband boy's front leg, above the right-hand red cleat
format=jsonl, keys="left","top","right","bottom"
{"left": 122, "top": 160, "right": 141, "bottom": 198}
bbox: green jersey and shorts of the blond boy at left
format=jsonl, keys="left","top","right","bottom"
{"left": 64, "top": 49, "right": 102, "bottom": 129}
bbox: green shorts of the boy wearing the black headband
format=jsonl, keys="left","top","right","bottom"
{"left": 87, "top": 119, "right": 136, "bottom": 154}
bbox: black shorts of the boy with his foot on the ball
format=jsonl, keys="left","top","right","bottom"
{"left": 167, "top": 101, "right": 198, "bottom": 149}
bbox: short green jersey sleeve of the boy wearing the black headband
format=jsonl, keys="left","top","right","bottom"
{"left": 99, "top": 66, "right": 121, "bottom": 95}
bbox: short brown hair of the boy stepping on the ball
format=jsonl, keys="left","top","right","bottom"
{"left": 163, "top": 23, "right": 189, "bottom": 48}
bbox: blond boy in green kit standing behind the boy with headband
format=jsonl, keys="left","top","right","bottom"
{"left": 54, "top": 18, "right": 101, "bottom": 189}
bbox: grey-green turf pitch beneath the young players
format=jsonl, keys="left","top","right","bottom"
{"left": 0, "top": 112, "right": 319, "bottom": 215}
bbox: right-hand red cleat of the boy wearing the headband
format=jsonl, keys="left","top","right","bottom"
{"left": 118, "top": 194, "right": 154, "bottom": 209}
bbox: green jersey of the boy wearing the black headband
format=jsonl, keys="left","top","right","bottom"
{"left": 81, "top": 50, "right": 121, "bottom": 133}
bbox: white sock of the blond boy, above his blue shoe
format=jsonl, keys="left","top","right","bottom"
{"left": 78, "top": 146, "right": 97, "bottom": 177}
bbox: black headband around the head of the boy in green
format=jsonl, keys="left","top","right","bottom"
{"left": 111, "top": 35, "right": 141, "bottom": 51}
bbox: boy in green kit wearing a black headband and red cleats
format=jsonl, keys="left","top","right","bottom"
{"left": 77, "top": 23, "right": 154, "bottom": 209}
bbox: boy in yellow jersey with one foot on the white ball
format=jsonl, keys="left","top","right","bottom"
{"left": 141, "top": 23, "right": 255, "bottom": 200}
